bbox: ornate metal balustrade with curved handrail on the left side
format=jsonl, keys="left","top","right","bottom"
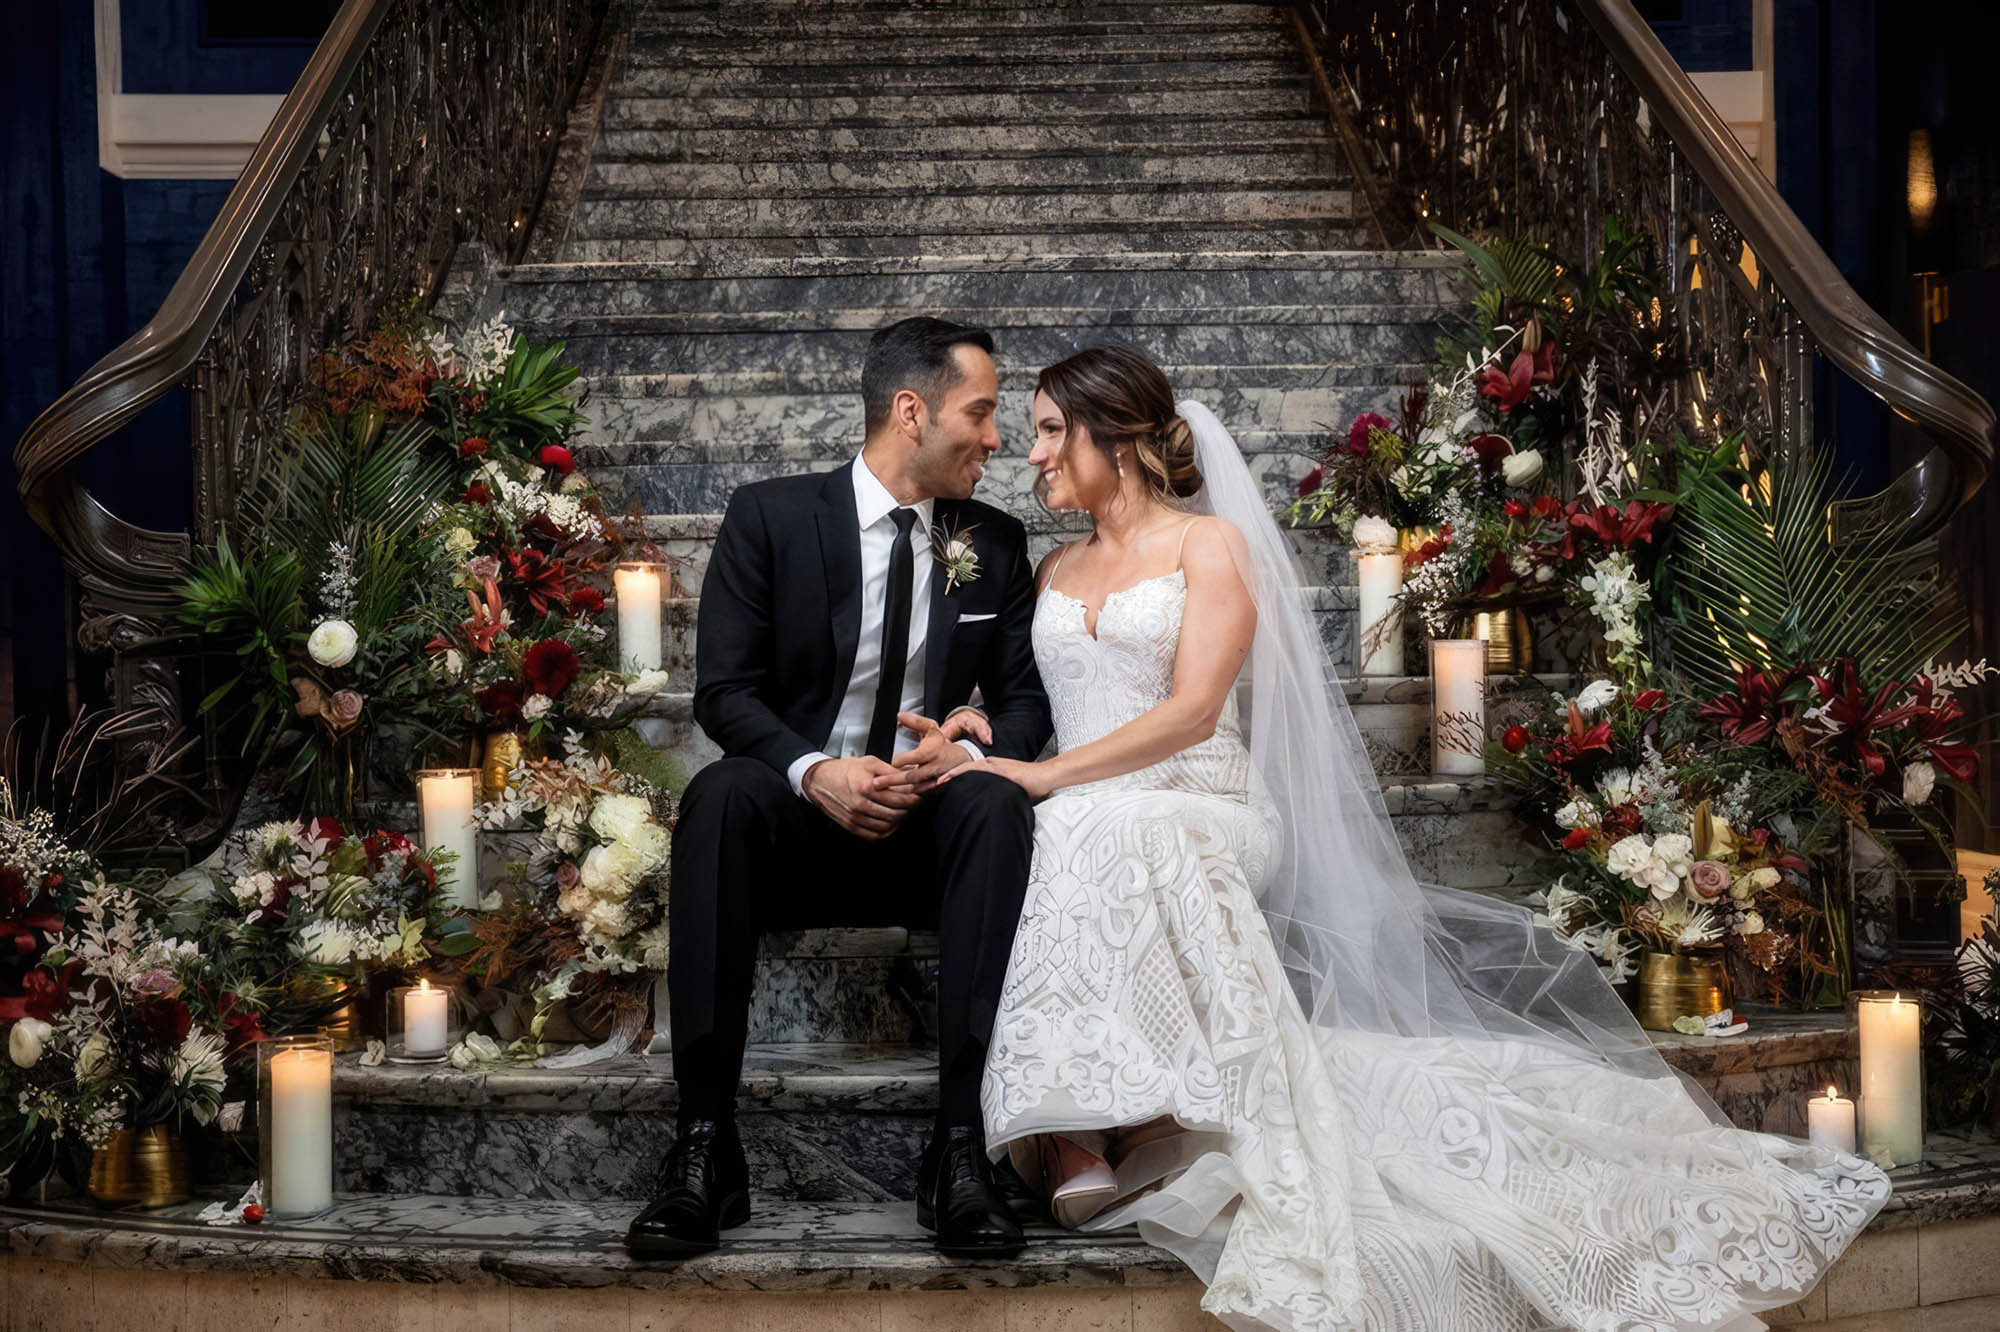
{"left": 14, "top": 0, "right": 608, "bottom": 820}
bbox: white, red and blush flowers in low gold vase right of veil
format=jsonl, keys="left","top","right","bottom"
{"left": 1494, "top": 680, "right": 1844, "bottom": 998}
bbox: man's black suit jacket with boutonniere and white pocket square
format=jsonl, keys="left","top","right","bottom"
{"left": 694, "top": 464, "right": 1052, "bottom": 772}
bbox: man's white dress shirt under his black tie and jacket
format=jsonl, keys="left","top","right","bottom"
{"left": 784, "top": 456, "right": 980, "bottom": 796}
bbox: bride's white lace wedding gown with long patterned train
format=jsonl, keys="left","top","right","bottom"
{"left": 982, "top": 572, "right": 1888, "bottom": 1332}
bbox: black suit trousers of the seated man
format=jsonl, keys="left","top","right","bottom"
{"left": 668, "top": 758, "right": 1034, "bottom": 1124}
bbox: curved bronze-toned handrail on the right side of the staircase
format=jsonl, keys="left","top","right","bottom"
{"left": 1572, "top": 0, "right": 1996, "bottom": 536}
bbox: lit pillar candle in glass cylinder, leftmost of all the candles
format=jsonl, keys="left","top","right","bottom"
{"left": 256, "top": 1032, "right": 334, "bottom": 1216}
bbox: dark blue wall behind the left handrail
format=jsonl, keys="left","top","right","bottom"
{"left": 0, "top": 0, "right": 310, "bottom": 722}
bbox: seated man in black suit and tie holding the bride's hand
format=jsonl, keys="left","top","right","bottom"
{"left": 626, "top": 318, "right": 1050, "bottom": 1258}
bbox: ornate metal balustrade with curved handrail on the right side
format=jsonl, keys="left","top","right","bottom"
{"left": 1296, "top": 0, "right": 1994, "bottom": 538}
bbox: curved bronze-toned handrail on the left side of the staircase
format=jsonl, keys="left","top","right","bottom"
{"left": 14, "top": 0, "right": 392, "bottom": 544}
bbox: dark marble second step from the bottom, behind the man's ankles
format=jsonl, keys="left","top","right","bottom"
{"left": 334, "top": 1010, "right": 1854, "bottom": 1208}
